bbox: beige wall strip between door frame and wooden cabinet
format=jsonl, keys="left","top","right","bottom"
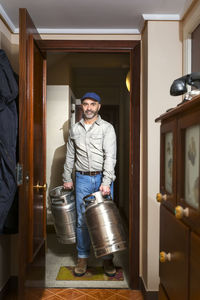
{"left": 141, "top": 21, "right": 182, "bottom": 291}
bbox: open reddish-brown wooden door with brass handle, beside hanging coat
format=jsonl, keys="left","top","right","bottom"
{"left": 18, "top": 9, "right": 46, "bottom": 300}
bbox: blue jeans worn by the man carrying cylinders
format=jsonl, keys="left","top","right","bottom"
{"left": 76, "top": 172, "right": 113, "bottom": 259}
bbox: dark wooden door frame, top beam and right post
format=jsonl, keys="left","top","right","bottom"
{"left": 38, "top": 40, "right": 141, "bottom": 289}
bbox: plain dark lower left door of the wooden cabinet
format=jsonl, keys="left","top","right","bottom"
{"left": 160, "top": 205, "right": 189, "bottom": 300}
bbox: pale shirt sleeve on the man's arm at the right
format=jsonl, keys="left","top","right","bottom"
{"left": 102, "top": 124, "right": 117, "bottom": 186}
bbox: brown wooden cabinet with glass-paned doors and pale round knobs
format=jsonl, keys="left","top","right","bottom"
{"left": 156, "top": 96, "right": 200, "bottom": 300}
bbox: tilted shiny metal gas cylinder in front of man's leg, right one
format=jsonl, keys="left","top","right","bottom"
{"left": 83, "top": 191, "right": 126, "bottom": 257}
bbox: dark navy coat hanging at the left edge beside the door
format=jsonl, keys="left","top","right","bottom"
{"left": 0, "top": 49, "right": 18, "bottom": 233}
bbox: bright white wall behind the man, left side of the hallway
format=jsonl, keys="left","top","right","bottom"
{"left": 46, "top": 85, "right": 74, "bottom": 223}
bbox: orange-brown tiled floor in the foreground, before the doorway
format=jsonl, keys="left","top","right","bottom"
{"left": 5, "top": 288, "right": 143, "bottom": 300}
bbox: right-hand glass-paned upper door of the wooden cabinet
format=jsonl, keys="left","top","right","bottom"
{"left": 177, "top": 109, "right": 200, "bottom": 234}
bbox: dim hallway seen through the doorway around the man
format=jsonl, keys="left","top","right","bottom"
{"left": 45, "top": 53, "right": 130, "bottom": 288}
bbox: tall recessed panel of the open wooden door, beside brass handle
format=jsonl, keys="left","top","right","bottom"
{"left": 31, "top": 38, "right": 46, "bottom": 257}
